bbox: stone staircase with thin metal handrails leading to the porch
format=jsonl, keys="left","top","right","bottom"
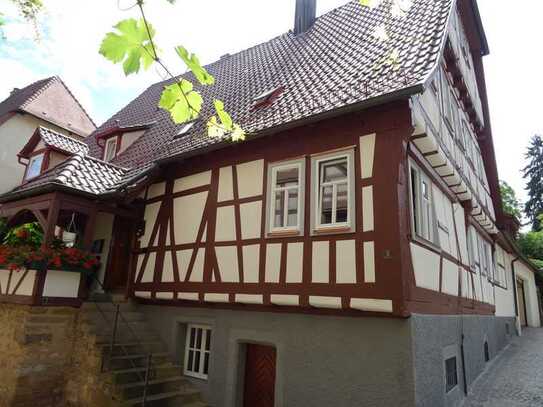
{"left": 80, "top": 295, "right": 208, "bottom": 407}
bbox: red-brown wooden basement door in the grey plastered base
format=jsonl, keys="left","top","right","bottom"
{"left": 243, "top": 344, "right": 276, "bottom": 407}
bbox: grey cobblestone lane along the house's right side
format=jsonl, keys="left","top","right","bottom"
{"left": 463, "top": 328, "right": 543, "bottom": 407}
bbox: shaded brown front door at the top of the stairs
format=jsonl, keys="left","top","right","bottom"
{"left": 105, "top": 216, "right": 134, "bottom": 290}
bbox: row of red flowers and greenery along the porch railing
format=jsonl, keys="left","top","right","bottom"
{"left": 0, "top": 245, "right": 100, "bottom": 273}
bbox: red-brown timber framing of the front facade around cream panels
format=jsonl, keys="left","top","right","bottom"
{"left": 130, "top": 101, "right": 493, "bottom": 317}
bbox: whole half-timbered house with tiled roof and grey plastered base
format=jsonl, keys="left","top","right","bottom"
{"left": 0, "top": 0, "right": 539, "bottom": 407}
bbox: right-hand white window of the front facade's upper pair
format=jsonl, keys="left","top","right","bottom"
{"left": 313, "top": 154, "right": 354, "bottom": 230}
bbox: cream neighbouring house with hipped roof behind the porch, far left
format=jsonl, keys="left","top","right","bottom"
{"left": 0, "top": 76, "right": 96, "bottom": 192}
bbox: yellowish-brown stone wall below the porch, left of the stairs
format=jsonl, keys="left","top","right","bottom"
{"left": 0, "top": 304, "right": 111, "bottom": 407}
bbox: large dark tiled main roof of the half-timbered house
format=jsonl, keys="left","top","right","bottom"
{"left": 87, "top": 0, "right": 451, "bottom": 167}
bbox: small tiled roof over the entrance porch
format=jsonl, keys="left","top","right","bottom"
{"left": 7, "top": 154, "right": 130, "bottom": 195}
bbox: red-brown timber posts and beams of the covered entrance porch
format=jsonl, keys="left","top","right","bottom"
{"left": 0, "top": 192, "right": 97, "bottom": 306}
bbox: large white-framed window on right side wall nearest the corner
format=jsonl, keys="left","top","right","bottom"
{"left": 410, "top": 163, "right": 438, "bottom": 244}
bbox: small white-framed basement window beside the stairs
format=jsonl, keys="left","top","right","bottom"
{"left": 184, "top": 324, "right": 211, "bottom": 379}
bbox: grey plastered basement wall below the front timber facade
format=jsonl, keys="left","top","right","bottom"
{"left": 140, "top": 306, "right": 414, "bottom": 407}
